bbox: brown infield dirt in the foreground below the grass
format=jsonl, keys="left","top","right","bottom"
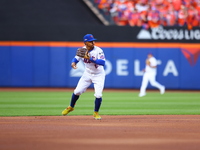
{"left": 0, "top": 115, "right": 200, "bottom": 150}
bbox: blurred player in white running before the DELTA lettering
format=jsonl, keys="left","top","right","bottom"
{"left": 139, "top": 53, "right": 165, "bottom": 97}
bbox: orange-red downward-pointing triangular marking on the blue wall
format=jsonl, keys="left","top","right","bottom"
{"left": 181, "top": 48, "right": 200, "bottom": 66}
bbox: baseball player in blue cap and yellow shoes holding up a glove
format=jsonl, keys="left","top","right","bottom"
{"left": 62, "top": 34, "right": 105, "bottom": 119}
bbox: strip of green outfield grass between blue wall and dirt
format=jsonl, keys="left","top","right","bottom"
{"left": 0, "top": 91, "right": 200, "bottom": 116}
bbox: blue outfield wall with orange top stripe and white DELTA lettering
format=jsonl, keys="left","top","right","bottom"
{"left": 0, "top": 42, "right": 200, "bottom": 90}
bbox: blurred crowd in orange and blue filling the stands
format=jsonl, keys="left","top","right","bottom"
{"left": 94, "top": 0, "right": 200, "bottom": 29}
